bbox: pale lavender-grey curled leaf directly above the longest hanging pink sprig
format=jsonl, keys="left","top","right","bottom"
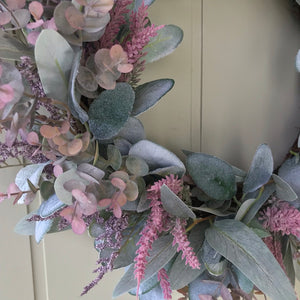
{"left": 129, "top": 140, "right": 185, "bottom": 175}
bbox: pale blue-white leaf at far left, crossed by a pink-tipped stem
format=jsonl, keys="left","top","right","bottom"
{"left": 15, "top": 163, "right": 48, "bottom": 204}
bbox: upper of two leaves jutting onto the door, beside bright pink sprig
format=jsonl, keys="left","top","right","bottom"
{"left": 143, "top": 25, "right": 183, "bottom": 63}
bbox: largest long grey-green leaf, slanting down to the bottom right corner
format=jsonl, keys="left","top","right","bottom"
{"left": 205, "top": 219, "right": 296, "bottom": 300}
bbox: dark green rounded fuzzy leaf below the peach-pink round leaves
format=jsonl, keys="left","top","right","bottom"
{"left": 88, "top": 82, "right": 135, "bottom": 140}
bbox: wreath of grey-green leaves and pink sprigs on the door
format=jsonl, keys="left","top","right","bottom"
{"left": 0, "top": 0, "right": 300, "bottom": 300}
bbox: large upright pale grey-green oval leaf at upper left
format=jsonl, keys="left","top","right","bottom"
{"left": 34, "top": 29, "right": 74, "bottom": 102}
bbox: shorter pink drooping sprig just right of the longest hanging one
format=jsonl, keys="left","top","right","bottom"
{"left": 171, "top": 218, "right": 200, "bottom": 269}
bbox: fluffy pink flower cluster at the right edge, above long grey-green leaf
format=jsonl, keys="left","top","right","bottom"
{"left": 260, "top": 201, "right": 300, "bottom": 238}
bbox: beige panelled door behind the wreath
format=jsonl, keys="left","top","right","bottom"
{"left": 0, "top": 0, "right": 300, "bottom": 300}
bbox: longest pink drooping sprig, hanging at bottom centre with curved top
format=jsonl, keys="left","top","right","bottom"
{"left": 134, "top": 174, "right": 182, "bottom": 297}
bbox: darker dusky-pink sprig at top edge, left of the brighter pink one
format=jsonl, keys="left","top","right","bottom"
{"left": 99, "top": 0, "right": 133, "bottom": 49}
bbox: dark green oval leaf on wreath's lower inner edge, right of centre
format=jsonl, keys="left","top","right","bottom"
{"left": 187, "top": 153, "right": 236, "bottom": 200}
